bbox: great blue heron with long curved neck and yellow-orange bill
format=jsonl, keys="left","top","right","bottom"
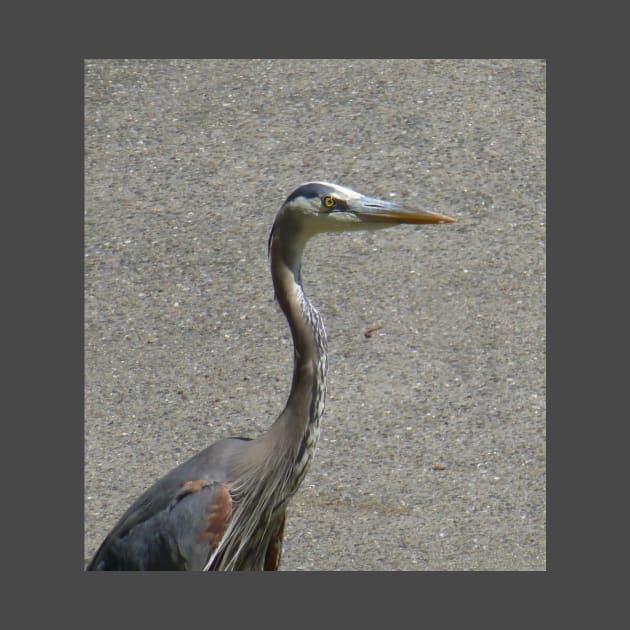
{"left": 87, "top": 182, "right": 454, "bottom": 571}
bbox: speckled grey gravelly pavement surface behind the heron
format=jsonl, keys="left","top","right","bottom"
{"left": 85, "top": 60, "right": 546, "bottom": 570}
